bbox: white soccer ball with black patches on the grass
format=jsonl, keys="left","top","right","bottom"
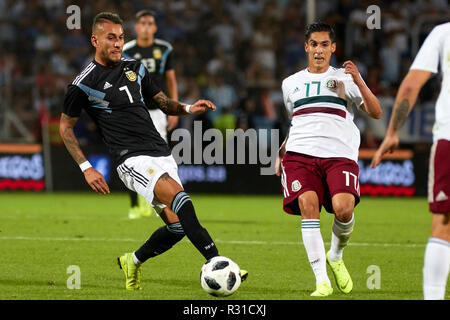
{"left": 200, "top": 256, "right": 241, "bottom": 297}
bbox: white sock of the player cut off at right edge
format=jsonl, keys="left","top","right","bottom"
{"left": 423, "top": 238, "right": 450, "bottom": 300}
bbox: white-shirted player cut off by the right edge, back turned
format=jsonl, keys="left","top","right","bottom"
{"left": 372, "top": 22, "right": 450, "bottom": 300}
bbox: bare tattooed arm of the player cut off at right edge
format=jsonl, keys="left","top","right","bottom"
{"left": 371, "top": 70, "right": 431, "bottom": 168}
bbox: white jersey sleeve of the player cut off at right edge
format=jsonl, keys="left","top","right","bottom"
{"left": 410, "top": 28, "right": 441, "bottom": 73}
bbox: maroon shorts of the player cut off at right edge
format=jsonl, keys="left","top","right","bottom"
{"left": 428, "top": 139, "right": 450, "bottom": 213}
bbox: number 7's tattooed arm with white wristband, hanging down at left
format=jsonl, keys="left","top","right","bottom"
{"left": 59, "top": 113, "right": 109, "bottom": 194}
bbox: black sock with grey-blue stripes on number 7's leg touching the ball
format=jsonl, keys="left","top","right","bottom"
{"left": 171, "top": 191, "right": 219, "bottom": 260}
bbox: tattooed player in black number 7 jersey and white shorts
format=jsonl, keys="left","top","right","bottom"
{"left": 60, "top": 12, "right": 247, "bottom": 290}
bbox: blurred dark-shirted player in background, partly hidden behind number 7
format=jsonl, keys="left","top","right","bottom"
{"left": 122, "top": 10, "right": 178, "bottom": 219}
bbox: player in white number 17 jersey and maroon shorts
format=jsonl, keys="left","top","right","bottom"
{"left": 277, "top": 22, "right": 381, "bottom": 297}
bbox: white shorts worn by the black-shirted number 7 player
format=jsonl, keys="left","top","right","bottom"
{"left": 117, "top": 155, "right": 183, "bottom": 212}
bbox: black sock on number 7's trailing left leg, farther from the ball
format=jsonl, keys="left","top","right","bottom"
{"left": 134, "top": 222, "right": 184, "bottom": 263}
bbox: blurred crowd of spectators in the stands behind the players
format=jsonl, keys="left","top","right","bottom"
{"left": 0, "top": 0, "right": 449, "bottom": 147}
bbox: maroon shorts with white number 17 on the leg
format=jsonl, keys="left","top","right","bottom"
{"left": 281, "top": 151, "right": 359, "bottom": 215}
